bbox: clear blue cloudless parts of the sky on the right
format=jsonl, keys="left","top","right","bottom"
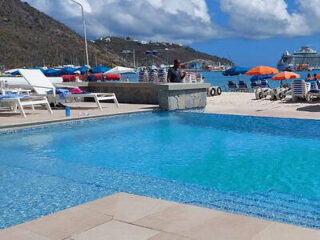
{"left": 191, "top": 0, "right": 320, "bottom": 67}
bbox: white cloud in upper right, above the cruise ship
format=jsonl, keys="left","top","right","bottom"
{"left": 220, "top": 0, "right": 312, "bottom": 38}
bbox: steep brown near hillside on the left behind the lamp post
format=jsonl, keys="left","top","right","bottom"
{"left": 0, "top": 0, "right": 123, "bottom": 68}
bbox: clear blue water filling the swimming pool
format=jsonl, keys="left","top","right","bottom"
{"left": 0, "top": 112, "right": 320, "bottom": 229}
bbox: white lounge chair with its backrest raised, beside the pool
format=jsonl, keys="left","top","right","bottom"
{"left": 19, "top": 69, "right": 119, "bottom": 110}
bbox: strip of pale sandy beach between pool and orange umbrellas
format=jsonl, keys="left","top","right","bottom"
{"left": 205, "top": 92, "right": 320, "bottom": 119}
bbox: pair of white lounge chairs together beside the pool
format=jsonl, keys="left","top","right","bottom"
{"left": 0, "top": 69, "right": 119, "bottom": 117}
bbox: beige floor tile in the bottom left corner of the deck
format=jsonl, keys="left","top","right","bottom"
{"left": 0, "top": 227, "right": 50, "bottom": 240}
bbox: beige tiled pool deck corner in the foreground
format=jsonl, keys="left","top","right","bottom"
{"left": 0, "top": 193, "right": 320, "bottom": 240}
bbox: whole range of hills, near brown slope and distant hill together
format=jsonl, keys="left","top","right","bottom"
{"left": 0, "top": 0, "right": 232, "bottom": 70}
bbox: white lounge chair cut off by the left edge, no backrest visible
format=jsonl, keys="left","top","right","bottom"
{"left": 0, "top": 95, "right": 53, "bottom": 118}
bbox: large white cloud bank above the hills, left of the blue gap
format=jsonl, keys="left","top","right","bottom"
{"left": 25, "top": 0, "right": 226, "bottom": 43}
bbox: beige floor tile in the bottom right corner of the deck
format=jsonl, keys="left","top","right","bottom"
{"left": 252, "top": 223, "right": 320, "bottom": 240}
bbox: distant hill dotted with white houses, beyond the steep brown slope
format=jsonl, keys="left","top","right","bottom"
{"left": 93, "top": 37, "right": 233, "bottom": 66}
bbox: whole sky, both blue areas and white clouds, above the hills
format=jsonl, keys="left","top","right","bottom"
{"left": 24, "top": 0, "right": 320, "bottom": 67}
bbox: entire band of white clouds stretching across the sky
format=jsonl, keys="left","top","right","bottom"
{"left": 25, "top": 0, "right": 320, "bottom": 43}
